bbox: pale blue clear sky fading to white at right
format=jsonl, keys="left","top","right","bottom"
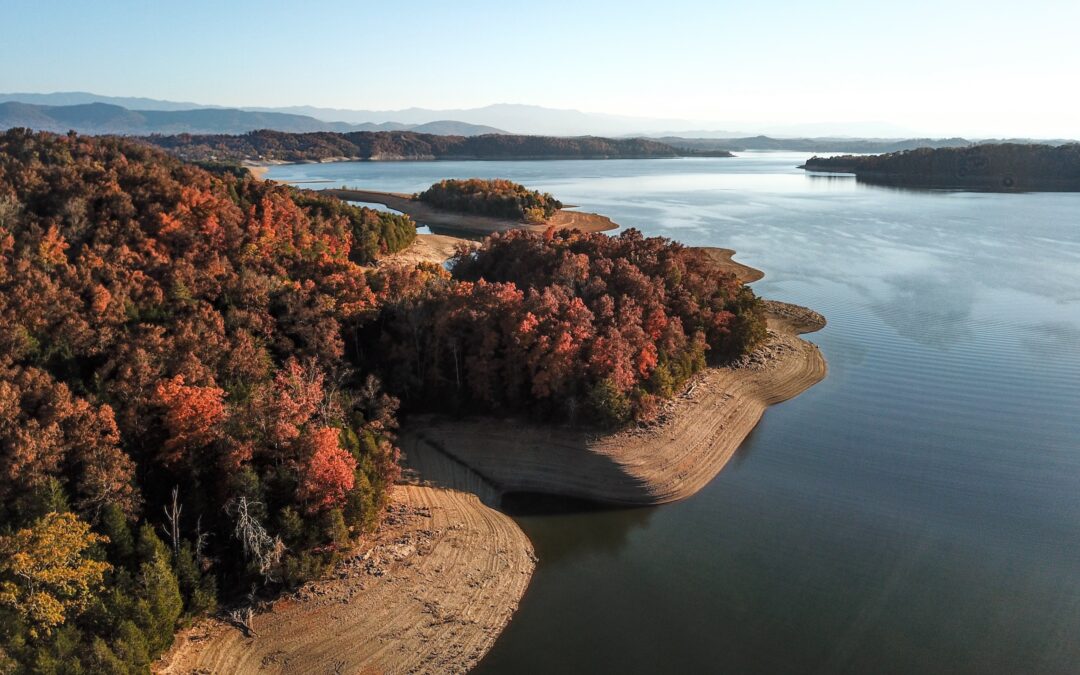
{"left": 0, "top": 0, "right": 1080, "bottom": 138}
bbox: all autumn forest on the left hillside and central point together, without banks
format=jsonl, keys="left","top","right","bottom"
{"left": 0, "top": 130, "right": 765, "bottom": 673}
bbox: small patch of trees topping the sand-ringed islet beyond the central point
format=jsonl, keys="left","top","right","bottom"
{"left": 416, "top": 178, "right": 563, "bottom": 224}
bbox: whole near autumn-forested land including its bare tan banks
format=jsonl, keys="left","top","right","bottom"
{"left": 0, "top": 130, "right": 826, "bottom": 673}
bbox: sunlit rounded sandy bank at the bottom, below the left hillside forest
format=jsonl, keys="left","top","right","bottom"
{"left": 156, "top": 485, "right": 536, "bottom": 674}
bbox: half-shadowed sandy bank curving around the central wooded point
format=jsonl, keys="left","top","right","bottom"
{"left": 400, "top": 302, "right": 826, "bottom": 505}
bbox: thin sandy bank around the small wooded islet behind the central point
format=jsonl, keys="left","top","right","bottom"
{"left": 323, "top": 188, "right": 619, "bottom": 234}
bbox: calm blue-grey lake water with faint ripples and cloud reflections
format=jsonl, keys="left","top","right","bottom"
{"left": 270, "top": 153, "right": 1080, "bottom": 675}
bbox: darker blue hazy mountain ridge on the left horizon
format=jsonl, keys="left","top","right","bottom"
{"left": 0, "top": 102, "right": 502, "bottom": 136}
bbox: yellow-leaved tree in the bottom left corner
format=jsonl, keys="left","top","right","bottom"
{"left": 0, "top": 512, "right": 111, "bottom": 636}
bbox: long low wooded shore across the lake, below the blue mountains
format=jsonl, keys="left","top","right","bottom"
{"left": 141, "top": 131, "right": 679, "bottom": 162}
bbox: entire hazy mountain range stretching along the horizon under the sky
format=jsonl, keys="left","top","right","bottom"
{"left": 0, "top": 92, "right": 1067, "bottom": 147}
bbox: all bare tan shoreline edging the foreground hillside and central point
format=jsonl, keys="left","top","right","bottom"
{"left": 153, "top": 234, "right": 827, "bottom": 675}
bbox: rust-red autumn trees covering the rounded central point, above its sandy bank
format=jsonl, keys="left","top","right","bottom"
{"left": 362, "top": 230, "right": 766, "bottom": 426}
